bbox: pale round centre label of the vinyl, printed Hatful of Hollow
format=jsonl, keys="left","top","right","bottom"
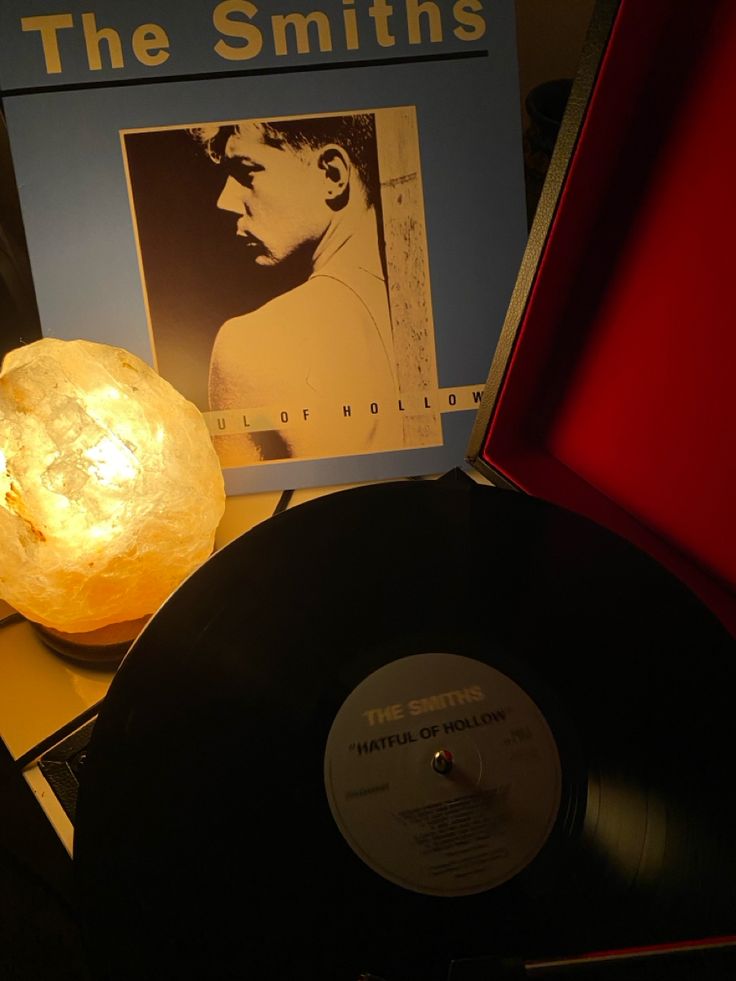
{"left": 325, "top": 653, "right": 561, "bottom": 896}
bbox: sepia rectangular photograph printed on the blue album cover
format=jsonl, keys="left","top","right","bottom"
{"left": 123, "top": 109, "right": 438, "bottom": 466}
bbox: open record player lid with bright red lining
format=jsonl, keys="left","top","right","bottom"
{"left": 468, "top": 0, "right": 736, "bottom": 634}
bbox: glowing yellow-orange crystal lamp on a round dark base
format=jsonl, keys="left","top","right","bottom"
{"left": 0, "top": 338, "right": 225, "bottom": 661}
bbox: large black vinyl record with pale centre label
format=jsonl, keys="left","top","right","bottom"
{"left": 74, "top": 474, "right": 736, "bottom": 981}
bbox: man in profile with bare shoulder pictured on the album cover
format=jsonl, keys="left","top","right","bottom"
{"left": 194, "top": 113, "right": 403, "bottom": 463}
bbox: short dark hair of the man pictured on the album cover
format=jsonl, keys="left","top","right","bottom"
{"left": 190, "top": 113, "right": 381, "bottom": 207}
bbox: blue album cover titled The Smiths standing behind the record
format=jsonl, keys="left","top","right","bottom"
{"left": 0, "top": 0, "right": 526, "bottom": 493}
